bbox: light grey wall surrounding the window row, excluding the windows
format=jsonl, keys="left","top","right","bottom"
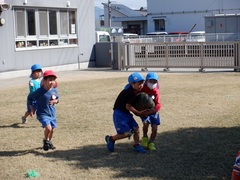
{"left": 0, "top": 0, "right": 95, "bottom": 72}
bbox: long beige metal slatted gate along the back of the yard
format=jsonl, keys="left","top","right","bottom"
{"left": 118, "top": 41, "right": 240, "bottom": 70}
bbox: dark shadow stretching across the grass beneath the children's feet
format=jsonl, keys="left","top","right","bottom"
{"left": 0, "top": 127, "right": 240, "bottom": 179}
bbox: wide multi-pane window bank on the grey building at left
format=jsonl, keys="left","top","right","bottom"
{"left": 14, "top": 8, "right": 77, "bottom": 50}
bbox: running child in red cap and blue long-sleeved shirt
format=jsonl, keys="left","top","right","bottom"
{"left": 28, "top": 70, "right": 59, "bottom": 151}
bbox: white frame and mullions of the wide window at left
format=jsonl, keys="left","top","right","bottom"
{"left": 13, "top": 7, "right": 78, "bottom": 51}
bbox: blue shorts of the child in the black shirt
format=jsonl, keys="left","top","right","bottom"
{"left": 113, "top": 109, "right": 138, "bottom": 134}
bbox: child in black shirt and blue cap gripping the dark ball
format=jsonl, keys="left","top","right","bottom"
{"left": 105, "top": 72, "right": 150, "bottom": 153}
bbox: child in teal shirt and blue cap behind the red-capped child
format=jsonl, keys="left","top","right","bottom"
{"left": 22, "top": 64, "right": 42, "bottom": 124}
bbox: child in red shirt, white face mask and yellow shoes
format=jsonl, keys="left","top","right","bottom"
{"left": 141, "top": 72, "right": 161, "bottom": 150}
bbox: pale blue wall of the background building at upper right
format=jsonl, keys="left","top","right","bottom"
{"left": 147, "top": 0, "right": 240, "bottom": 32}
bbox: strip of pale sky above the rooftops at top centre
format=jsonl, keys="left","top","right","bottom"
{"left": 95, "top": 0, "right": 147, "bottom": 9}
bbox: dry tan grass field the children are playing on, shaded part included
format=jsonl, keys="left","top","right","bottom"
{"left": 0, "top": 72, "right": 240, "bottom": 180}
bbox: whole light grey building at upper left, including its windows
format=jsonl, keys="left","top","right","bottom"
{"left": 0, "top": 0, "right": 95, "bottom": 73}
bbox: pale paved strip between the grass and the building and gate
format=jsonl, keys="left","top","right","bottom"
{"left": 0, "top": 68, "right": 233, "bottom": 89}
